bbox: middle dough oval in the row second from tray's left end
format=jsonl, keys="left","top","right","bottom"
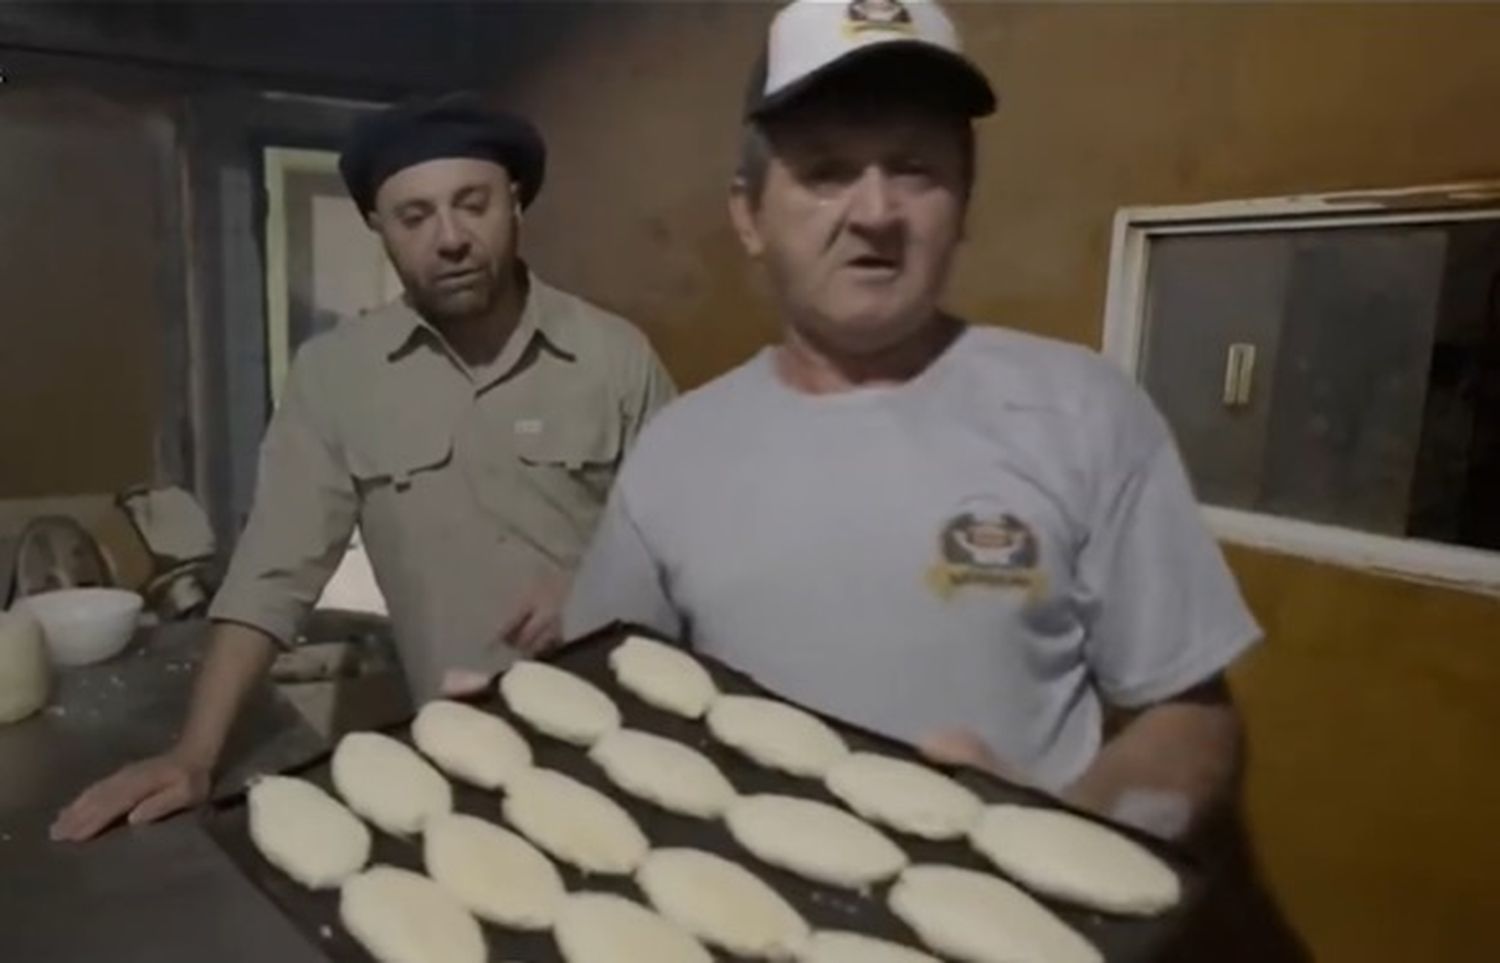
{"left": 422, "top": 815, "right": 567, "bottom": 930}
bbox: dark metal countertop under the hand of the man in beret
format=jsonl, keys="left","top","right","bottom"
{"left": 0, "top": 624, "right": 334, "bottom": 963}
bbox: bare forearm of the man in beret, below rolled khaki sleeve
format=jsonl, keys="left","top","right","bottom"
{"left": 173, "top": 623, "right": 276, "bottom": 768}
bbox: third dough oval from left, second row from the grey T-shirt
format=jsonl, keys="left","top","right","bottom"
{"left": 725, "top": 795, "right": 906, "bottom": 890}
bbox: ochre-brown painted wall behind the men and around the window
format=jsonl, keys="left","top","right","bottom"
{"left": 504, "top": 3, "right": 1500, "bottom": 963}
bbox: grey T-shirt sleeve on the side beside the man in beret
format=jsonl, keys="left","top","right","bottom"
{"left": 563, "top": 483, "right": 683, "bottom": 639}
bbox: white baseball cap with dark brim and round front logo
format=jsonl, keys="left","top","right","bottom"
{"left": 746, "top": 0, "right": 996, "bottom": 117}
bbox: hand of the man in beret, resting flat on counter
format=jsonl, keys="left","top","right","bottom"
{"left": 51, "top": 753, "right": 212, "bottom": 843}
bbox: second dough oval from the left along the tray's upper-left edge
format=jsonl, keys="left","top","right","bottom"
{"left": 333, "top": 732, "right": 453, "bottom": 836}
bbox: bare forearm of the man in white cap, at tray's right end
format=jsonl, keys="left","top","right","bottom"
{"left": 1064, "top": 699, "right": 1242, "bottom": 836}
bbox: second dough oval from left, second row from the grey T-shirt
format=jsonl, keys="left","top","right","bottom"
{"left": 588, "top": 729, "right": 737, "bottom": 819}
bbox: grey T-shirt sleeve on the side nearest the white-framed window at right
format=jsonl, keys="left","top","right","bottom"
{"left": 1079, "top": 398, "right": 1260, "bottom": 708}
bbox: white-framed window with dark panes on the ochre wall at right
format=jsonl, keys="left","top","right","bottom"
{"left": 1106, "top": 185, "right": 1500, "bottom": 590}
